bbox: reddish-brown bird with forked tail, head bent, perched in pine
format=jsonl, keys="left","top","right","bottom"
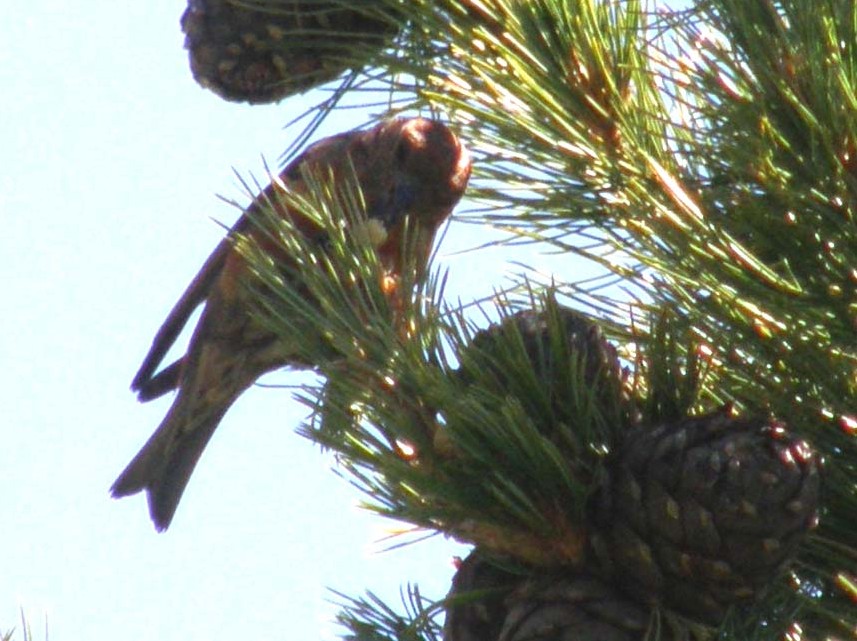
{"left": 110, "top": 117, "right": 472, "bottom": 531}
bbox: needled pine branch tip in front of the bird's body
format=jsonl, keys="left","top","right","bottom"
{"left": 239, "top": 164, "right": 636, "bottom": 563}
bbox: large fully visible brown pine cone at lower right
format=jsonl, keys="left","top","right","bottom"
{"left": 591, "top": 412, "right": 819, "bottom": 625}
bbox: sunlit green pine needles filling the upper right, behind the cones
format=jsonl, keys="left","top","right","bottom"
{"left": 364, "top": 6, "right": 857, "bottom": 636}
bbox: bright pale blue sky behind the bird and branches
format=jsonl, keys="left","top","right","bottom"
{"left": 0, "top": 0, "right": 596, "bottom": 641}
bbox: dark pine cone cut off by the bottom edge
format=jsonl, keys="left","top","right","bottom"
{"left": 443, "top": 551, "right": 689, "bottom": 641}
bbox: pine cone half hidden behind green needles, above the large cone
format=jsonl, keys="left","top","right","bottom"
{"left": 459, "top": 301, "right": 633, "bottom": 460}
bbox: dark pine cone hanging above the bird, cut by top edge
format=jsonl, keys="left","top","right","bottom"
{"left": 181, "top": 0, "right": 397, "bottom": 103}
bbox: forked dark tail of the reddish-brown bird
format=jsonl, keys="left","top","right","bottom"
{"left": 110, "top": 392, "right": 231, "bottom": 531}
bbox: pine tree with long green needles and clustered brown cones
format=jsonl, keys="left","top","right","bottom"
{"left": 196, "top": 0, "right": 857, "bottom": 641}
